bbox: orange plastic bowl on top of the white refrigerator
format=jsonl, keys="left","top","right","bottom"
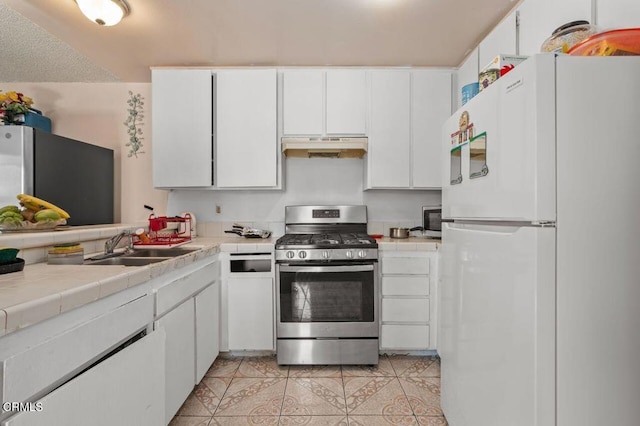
{"left": 567, "top": 28, "right": 640, "bottom": 56}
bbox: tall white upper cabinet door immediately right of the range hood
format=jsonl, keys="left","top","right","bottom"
{"left": 367, "top": 70, "right": 411, "bottom": 188}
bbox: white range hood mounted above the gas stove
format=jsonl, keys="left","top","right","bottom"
{"left": 282, "top": 137, "right": 367, "bottom": 158}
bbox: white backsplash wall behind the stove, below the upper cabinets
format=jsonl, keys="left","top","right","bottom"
{"left": 167, "top": 158, "right": 440, "bottom": 223}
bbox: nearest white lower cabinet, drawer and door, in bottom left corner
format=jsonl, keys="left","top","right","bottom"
{"left": 0, "top": 292, "right": 165, "bottom": 426}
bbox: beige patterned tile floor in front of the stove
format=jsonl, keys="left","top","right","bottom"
{"left": 170, "top": 355, "right": 447, "bottom": 426}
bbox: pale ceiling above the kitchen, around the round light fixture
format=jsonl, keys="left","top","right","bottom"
{"left": 0, "top": 0, "right": 517, "bottom": 82}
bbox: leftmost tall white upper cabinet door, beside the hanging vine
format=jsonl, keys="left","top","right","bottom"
{"left": 151, "top": 69, "right": 213, "bottom": 188}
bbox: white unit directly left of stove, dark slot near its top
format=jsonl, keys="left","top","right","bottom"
{"left": 220, "top": 252, "right": 275, "bottom": 351}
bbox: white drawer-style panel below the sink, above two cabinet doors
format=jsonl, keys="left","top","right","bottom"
{"left": 156, "top": 262, "right": 219, "bottom": 317}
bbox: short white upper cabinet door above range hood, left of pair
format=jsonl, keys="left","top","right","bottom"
{"left": 282, "top": 69, "right": 324, "bottom": 135}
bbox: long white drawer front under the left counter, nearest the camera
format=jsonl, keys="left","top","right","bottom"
{"left": 0, "top": 295, "right": 153, "bottom": 402}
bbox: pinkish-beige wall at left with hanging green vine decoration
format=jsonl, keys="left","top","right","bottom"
{"left": 0, "top": 83, "right": 167, "bottom": 222}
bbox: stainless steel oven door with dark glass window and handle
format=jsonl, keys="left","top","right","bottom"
{"left": 276, "top": 263, "right": 379, "bottom": 338}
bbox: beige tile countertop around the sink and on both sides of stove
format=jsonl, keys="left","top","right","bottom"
{"left": 0, "top": 230, "right": 440, "bottom": 336}
